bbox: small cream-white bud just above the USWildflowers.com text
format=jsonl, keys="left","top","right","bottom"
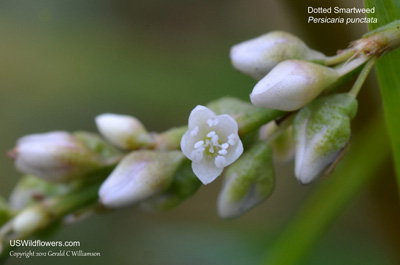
{"left": 12, "top": 204, "right": 50, "bottom": 235}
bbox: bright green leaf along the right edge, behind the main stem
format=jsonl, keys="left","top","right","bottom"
{"left": 364, "top": 0, "right": 400, "bottom": 194}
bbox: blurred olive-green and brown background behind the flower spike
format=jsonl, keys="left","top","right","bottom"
{"left": 0, "top": 0, "right": 400, "bottom": 265}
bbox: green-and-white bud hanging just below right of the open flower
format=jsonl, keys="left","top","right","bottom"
{"left": 217, "top": 142, "right": 274, "bottom": 218}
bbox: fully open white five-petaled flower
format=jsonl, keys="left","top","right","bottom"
{"left": 181, "top": 106, "right": 243, "bottom": 184}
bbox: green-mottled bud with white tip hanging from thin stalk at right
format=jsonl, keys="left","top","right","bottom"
{"left": 294, "top": 94, "right": 357, "bottom": 184}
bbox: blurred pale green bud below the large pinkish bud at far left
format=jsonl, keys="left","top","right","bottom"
{"left": 10, "top": 175, "right": 71, "bottom": 211}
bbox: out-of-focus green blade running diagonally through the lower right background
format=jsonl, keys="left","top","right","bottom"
{"left": 263, "top": 113, "right": 390, "bottom": 265}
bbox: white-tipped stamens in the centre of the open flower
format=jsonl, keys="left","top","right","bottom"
{"left": 190, "top": 119, "right": 237, "bottom": 168}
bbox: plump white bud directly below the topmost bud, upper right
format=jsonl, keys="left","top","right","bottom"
{"left": 250, "top": 60, "right": 339, "bottom": 111}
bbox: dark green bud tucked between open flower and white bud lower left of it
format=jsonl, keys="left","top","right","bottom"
{"left": 140, "top": 159, "right": 201, "bottom": 211}
